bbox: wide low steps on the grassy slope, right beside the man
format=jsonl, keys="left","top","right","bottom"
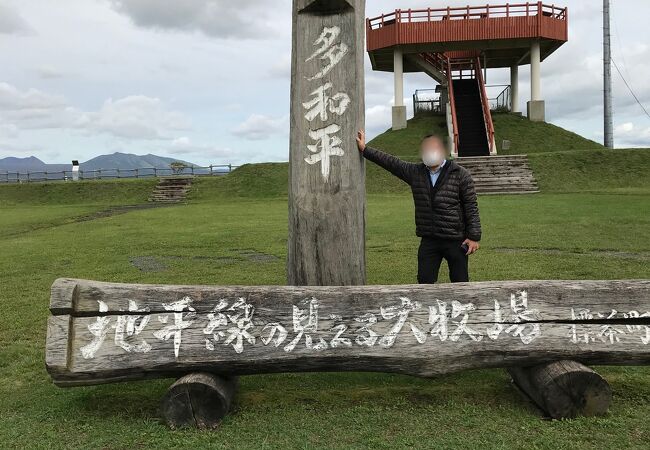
{"left": 455, "top": 155, "right": 539, "bottom": 194}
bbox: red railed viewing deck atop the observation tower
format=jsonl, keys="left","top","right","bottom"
{"left": 366, "top": 2, "right": 569, "bottom": 72}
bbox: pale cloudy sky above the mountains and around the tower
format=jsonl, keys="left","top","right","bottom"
{"left": 0, "top": 0, "right": 650, "bottom": 165}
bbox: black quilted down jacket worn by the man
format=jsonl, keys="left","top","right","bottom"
{"left": 363, "top": 146, "right": 481, "bottom": 241}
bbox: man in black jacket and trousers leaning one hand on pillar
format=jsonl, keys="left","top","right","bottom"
{"left": 357, "top": 130, "right": 481, "bottom": 283}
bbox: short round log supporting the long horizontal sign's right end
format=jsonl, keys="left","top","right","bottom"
{"left": 508, "top": 360, "right": 612, "bottom": 419}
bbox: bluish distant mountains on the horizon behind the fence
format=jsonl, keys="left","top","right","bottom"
{"left": 0, "top": 152, "right": 196, "bottom": 172}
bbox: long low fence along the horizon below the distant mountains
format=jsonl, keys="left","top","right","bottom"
{"left": 0, "top": 164, "right": 238, "bottom": 183}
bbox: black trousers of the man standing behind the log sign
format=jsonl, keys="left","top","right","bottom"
{"left": 418, "top": 237, "right": 469, "bottom": 284}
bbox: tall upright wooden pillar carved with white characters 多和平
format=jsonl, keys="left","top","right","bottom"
{"left": 287, "top": 0, "right": 365, "bottom": 286}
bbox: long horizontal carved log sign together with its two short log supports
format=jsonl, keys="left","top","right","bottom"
{"left": 46, "top": 278, "right": 650, "bottom": 427}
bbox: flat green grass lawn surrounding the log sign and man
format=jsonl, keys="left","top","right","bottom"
{"left": 0, "top": 187, "right": 650, "bottom": 450}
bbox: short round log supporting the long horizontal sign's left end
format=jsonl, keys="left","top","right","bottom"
{"left": 161, "top": 372, "right": 237, "bottom": 429}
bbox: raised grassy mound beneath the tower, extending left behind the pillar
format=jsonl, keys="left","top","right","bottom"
{"left": 186, "top": 114, "right": 650, "bottom": 200}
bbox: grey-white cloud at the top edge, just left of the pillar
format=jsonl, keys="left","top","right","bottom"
{"left": 108, "top": 0, "right": 279, "bottom": 39}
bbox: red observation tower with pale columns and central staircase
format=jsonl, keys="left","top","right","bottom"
{"left": 366, "top": 2, "right": 569, "bottom": 157}
